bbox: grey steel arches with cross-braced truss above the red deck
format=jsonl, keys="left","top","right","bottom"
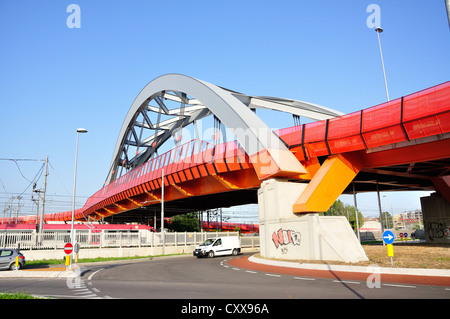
{"left": 106, "top": 74, "right": 342, "bottom": 184}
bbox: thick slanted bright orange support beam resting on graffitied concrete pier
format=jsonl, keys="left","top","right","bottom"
{"left": 293, "top": 153, "right": 363, "bottom": 213}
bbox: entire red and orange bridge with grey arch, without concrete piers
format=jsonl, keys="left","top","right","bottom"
{"left": 7, "top": 74, "right": 450, "bottom": 262}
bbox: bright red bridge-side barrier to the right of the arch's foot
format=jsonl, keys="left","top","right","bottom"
{"left": 276, "top": 82, "right": 450, "bottom": 160}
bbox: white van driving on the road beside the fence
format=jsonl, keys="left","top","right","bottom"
{"left": 194, "top": 236, "right": 241, "bottom": 258}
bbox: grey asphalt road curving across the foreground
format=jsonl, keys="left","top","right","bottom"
{"left": 0, "top": 255, "right": 450, "bottom": 307}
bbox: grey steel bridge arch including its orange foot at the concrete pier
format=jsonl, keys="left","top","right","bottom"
{"left": 106, "top": 74, "right": 342, "bottom": 184}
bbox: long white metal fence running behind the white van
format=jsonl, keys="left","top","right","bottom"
{"left": 0, "top": 231, "right": 259, "bottom": 250}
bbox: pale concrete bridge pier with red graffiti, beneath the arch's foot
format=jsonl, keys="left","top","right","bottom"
{"left": 258, "top": 179, "right": 368, "bottom": 262}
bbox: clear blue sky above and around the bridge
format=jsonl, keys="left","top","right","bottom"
{"left": 0, "top": 0, "right": 450, "bottom": 217}
